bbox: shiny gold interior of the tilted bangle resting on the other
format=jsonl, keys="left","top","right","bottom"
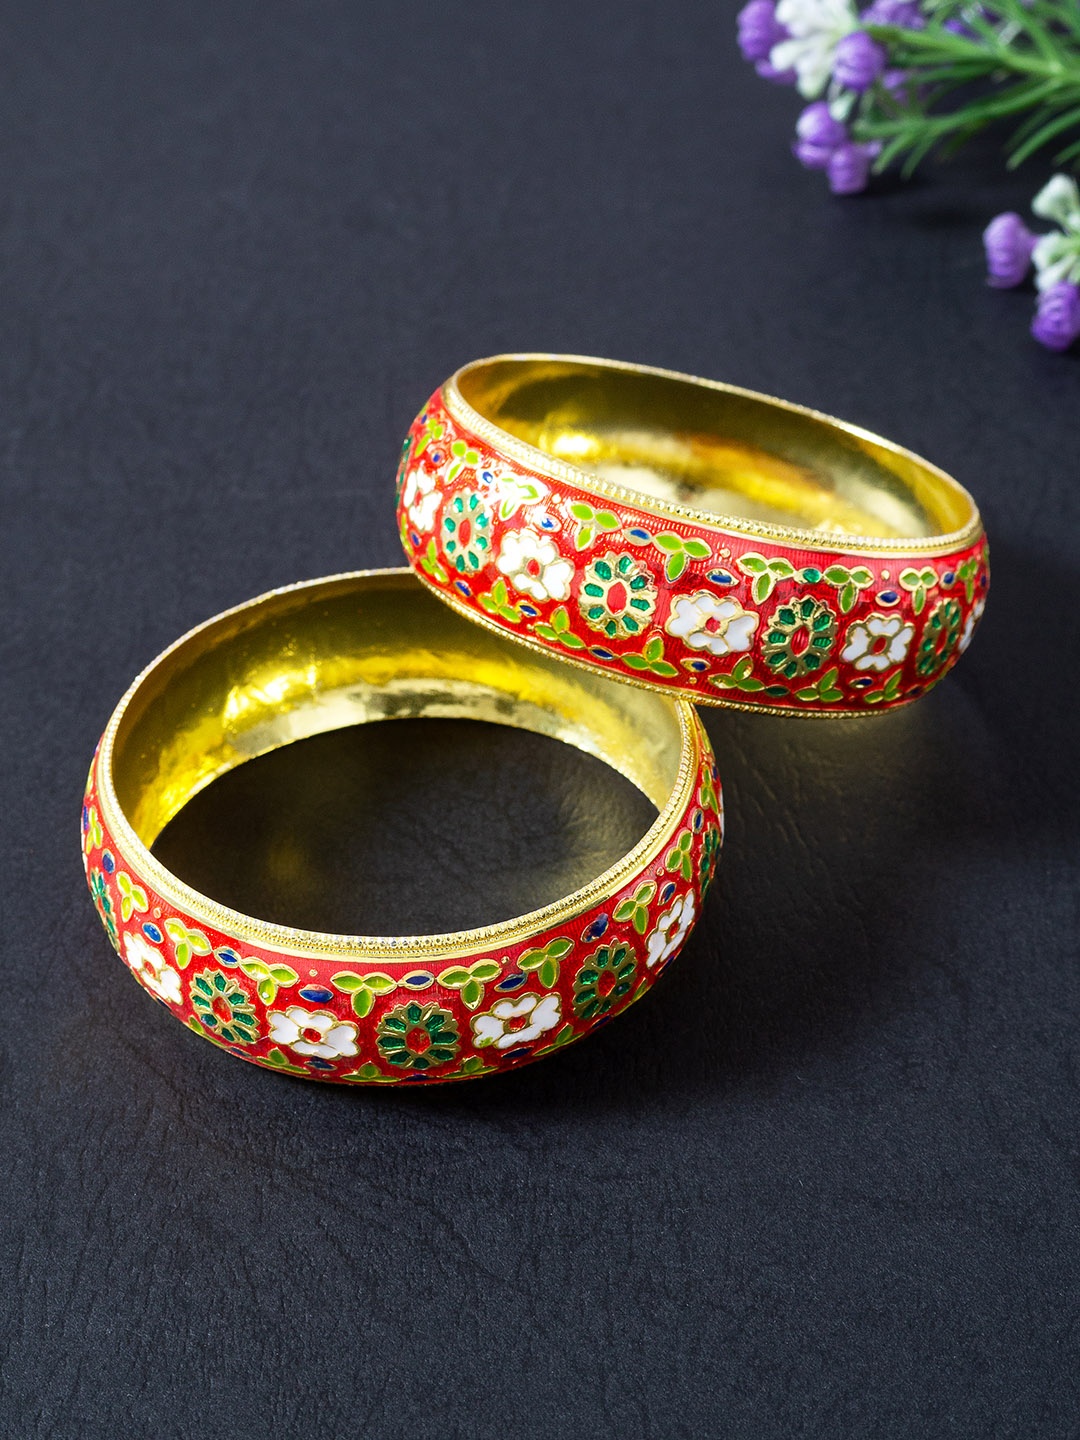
{"left": 451, "top": 356, "right": 978, "bottom": 540}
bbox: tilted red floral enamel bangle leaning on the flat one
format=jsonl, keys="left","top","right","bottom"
{"left": 397, "top": 356, "right": 989, "bottom": 714}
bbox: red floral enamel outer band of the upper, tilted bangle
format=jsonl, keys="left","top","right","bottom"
{"left": 399, "top": 390, "right": 989, "bottom": 714}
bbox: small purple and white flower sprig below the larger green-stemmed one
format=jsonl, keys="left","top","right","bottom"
{"left": 982, "top": 174, "right": 1080, "bottom": 350}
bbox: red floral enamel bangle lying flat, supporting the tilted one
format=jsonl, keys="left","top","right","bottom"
{"left": 82, "top": 570, "right": 721, "bottom": 1084}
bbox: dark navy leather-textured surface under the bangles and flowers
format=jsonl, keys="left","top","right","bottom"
{"left": 0, "top": 0, "right": 1080, "bottom": 1440}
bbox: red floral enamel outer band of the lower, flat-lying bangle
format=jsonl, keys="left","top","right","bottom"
{"left": 82, "top": 725, "right": 723, "bottom": 1084}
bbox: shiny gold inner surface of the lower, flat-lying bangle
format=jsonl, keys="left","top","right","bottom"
{"left": 105, "top": 570, "right": 683, "bottom": 847}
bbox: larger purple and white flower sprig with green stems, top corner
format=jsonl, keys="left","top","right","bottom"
{"left": 739, "top": 0, "right": 1080, "bottom": 194}
